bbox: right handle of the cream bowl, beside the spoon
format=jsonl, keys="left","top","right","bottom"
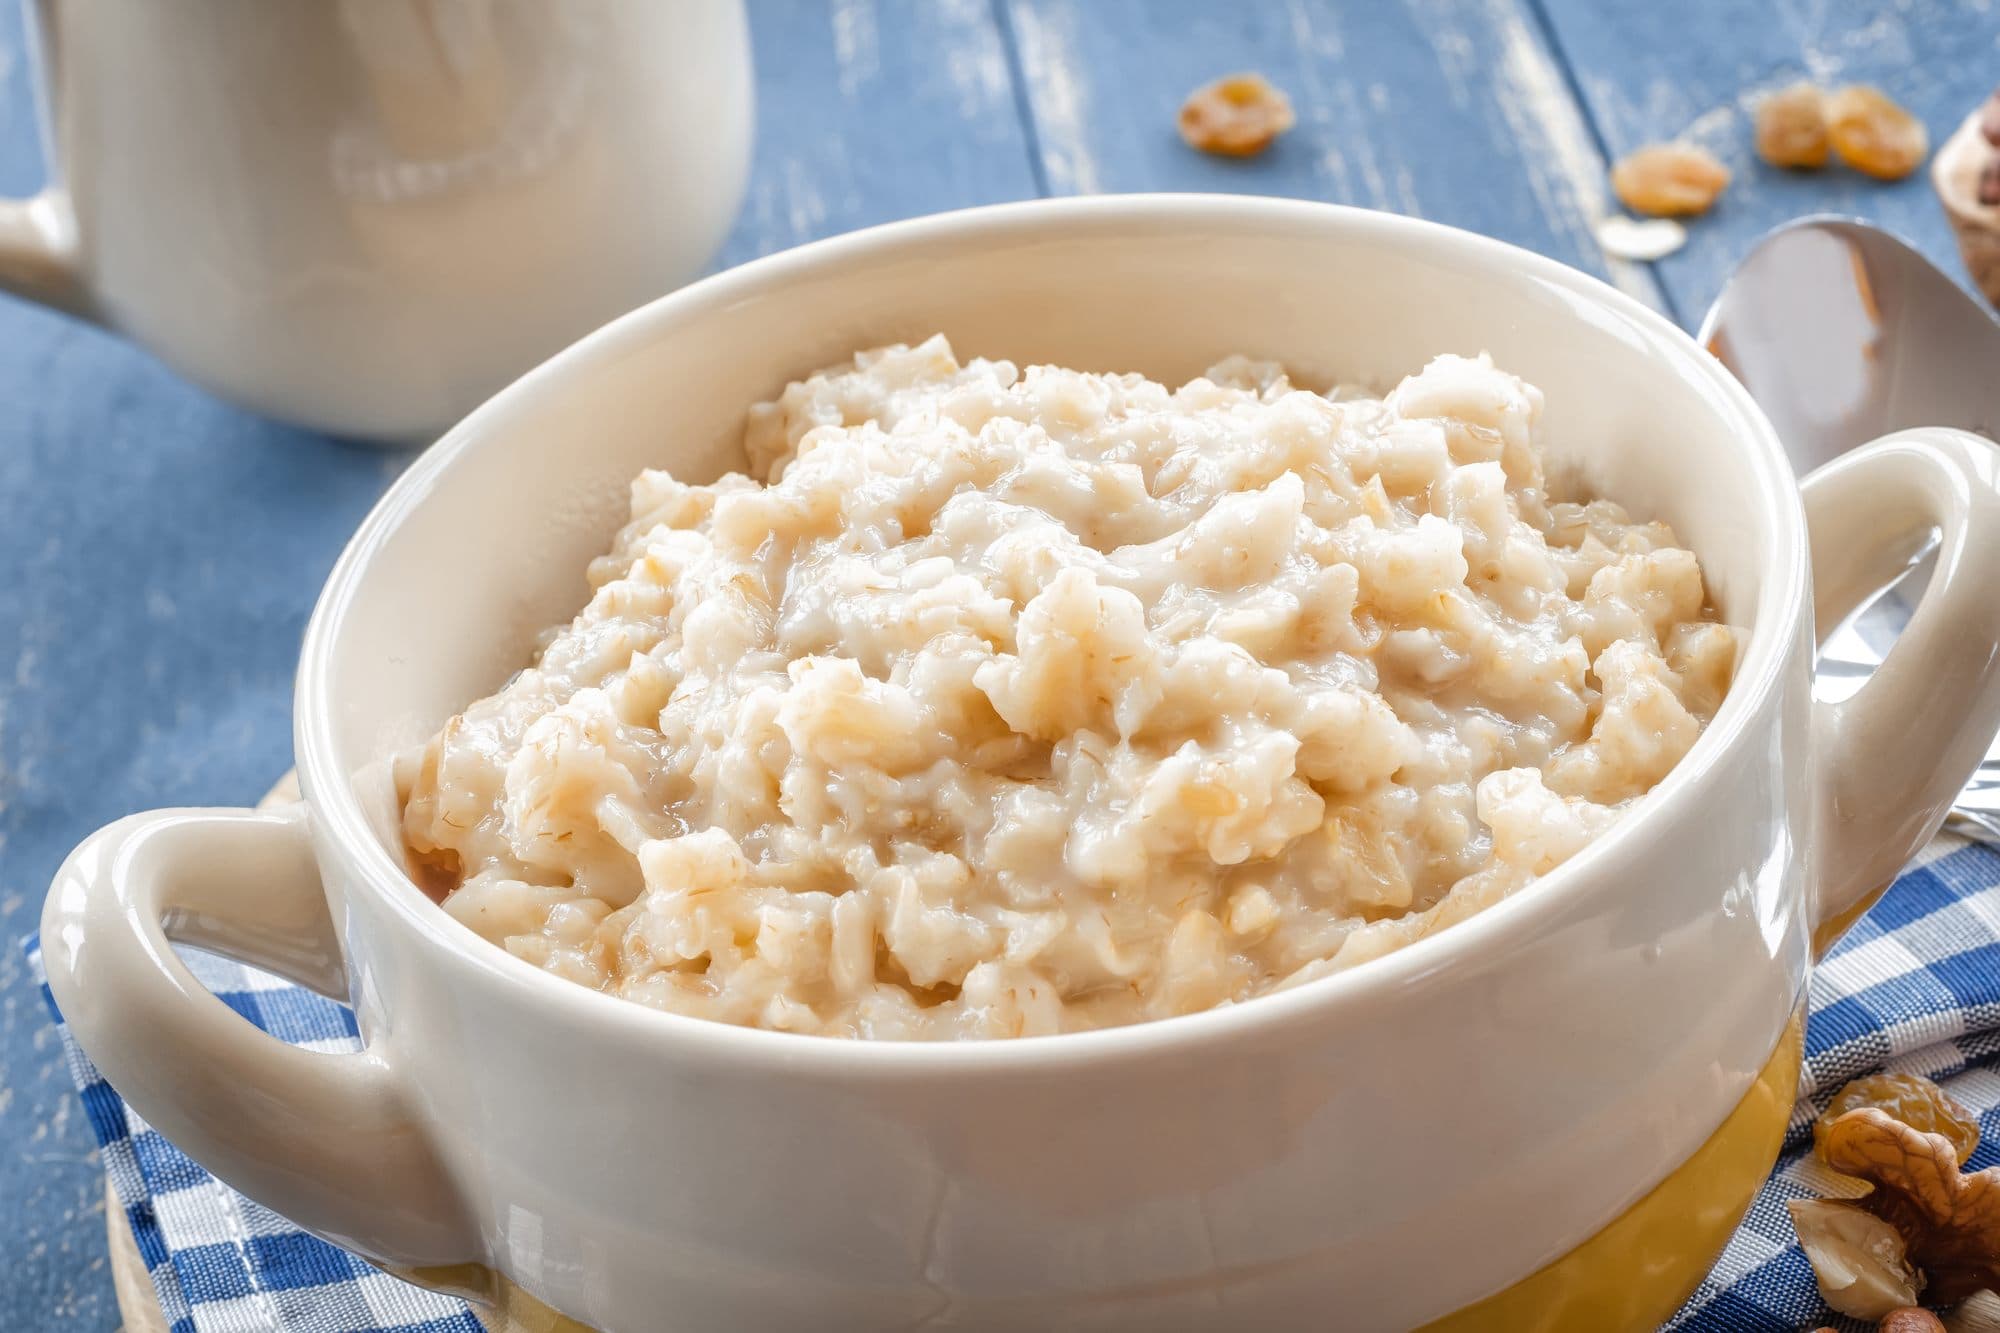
{"left": 1800, "top": 426, "right": 2000, "bottom": 953}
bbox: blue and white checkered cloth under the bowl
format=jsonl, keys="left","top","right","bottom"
{"left": 28, "top": 839, "right": 2000, "bottom": 1333}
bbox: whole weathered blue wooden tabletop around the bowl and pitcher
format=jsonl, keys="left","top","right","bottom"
{"left": 0, "top": 0, "right": 2000, "bottom": 1329}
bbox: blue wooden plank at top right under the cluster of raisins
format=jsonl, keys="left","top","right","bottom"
{"left": 1540, "top": 0, "right": 2000, "bottom": 326}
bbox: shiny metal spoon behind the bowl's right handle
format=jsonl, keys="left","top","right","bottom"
{"left": 1700, "top": 216, "right": 2000, "bottom": 847}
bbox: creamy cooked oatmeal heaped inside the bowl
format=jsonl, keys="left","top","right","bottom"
{"left": 400, "top": 338, "right": 1736, "bottom": 1039}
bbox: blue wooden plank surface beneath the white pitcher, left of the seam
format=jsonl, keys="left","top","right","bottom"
{"left": 0, "top": 0, "right": 1036, "bottom": 1331}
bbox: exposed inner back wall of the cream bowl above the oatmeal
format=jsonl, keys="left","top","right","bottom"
{"left": 316, "top": 198, "right": 1798, "bottom": 863}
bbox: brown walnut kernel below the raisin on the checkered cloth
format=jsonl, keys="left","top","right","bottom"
{"left": 1818, "top": 1107, "right": 2000, "bottom": 1305}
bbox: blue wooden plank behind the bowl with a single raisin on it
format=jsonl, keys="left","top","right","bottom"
{"left": 1002, "top": 0, "right": 1660, "bottom": 304}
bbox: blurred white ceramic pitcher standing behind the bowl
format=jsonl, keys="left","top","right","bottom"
{"left": 0, "top": 0, "right": 752, "bottom": 440}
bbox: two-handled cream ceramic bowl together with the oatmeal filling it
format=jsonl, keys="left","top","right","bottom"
{"left": 44, "top": 196, "right": 2000, "bottom": 1329}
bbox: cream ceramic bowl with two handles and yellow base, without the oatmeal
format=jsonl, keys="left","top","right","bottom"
{"left": 44, "top": 196, "right": 2000, "bottom": 1329}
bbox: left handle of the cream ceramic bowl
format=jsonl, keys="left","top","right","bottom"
{"left": 42, "top": 805, "right": 478, "bottom": 1265}
